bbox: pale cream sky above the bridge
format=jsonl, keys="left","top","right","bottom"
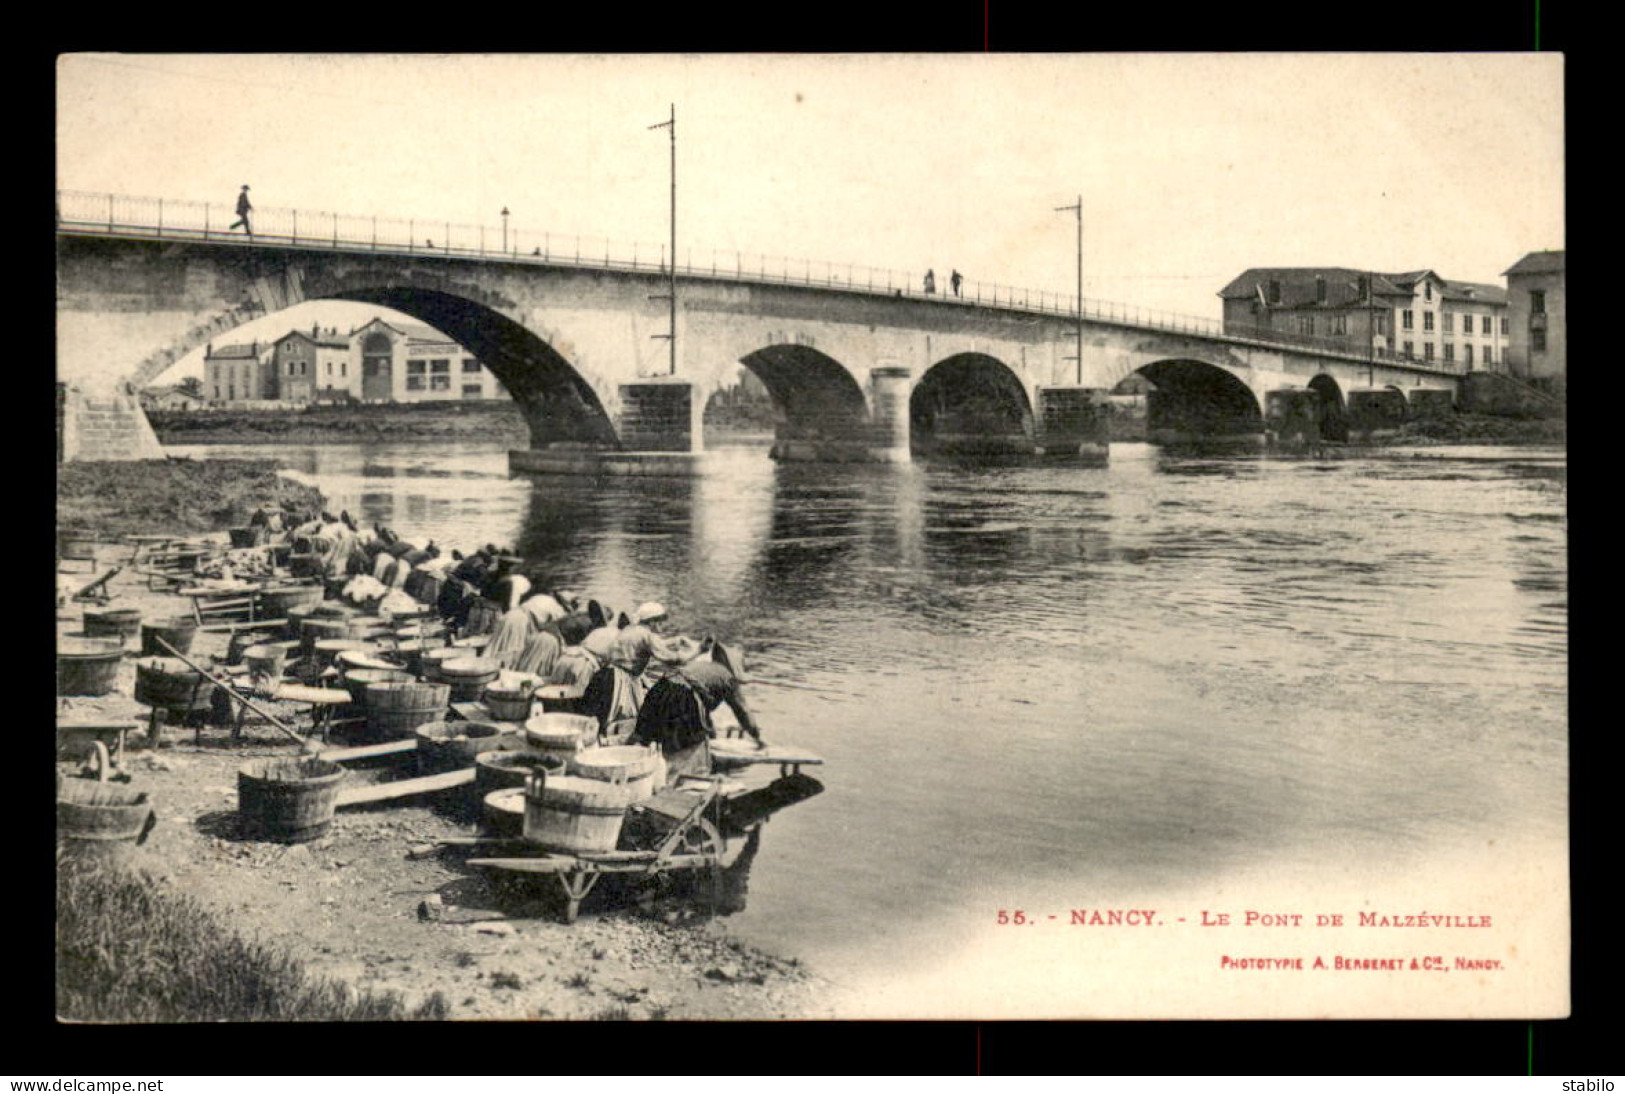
{"left": 57, "top": 54, "right": 1565, "bottom": 380}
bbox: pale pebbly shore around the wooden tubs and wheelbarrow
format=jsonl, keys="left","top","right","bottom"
{"left": 57, "top": 545, "right": 832, "bottom": 1019}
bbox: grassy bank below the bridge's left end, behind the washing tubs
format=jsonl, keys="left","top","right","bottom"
{"left": 57, "top": 458, "right": 323, "bottom": 535}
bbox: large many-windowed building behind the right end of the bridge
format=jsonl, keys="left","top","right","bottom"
{"left": 1219, "top": 267, "right": 1506, "bottom": 372}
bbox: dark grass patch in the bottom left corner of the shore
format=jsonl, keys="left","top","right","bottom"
{"left": 57, "top": 855, "right": 450, "bottom": 1022}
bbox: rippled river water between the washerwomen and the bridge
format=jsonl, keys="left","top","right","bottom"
{"left": 161, "top": 442, "right": 1568, "bottom": 1016}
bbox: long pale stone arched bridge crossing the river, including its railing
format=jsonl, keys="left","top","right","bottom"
{"left": 57, "top": 192, "right": 1459, "bottom": 467}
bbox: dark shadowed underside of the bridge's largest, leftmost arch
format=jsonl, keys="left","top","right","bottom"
{"left": 320, "top": 284, "right": 619, "bottom": 449}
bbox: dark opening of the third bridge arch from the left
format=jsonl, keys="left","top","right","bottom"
{"left": 908, "top": 353, "right": 1034, "bottom": 454}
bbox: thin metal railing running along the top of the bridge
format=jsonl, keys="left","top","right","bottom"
{"left": 57, "top": 190, "right": 1464, "bottom": 374}
